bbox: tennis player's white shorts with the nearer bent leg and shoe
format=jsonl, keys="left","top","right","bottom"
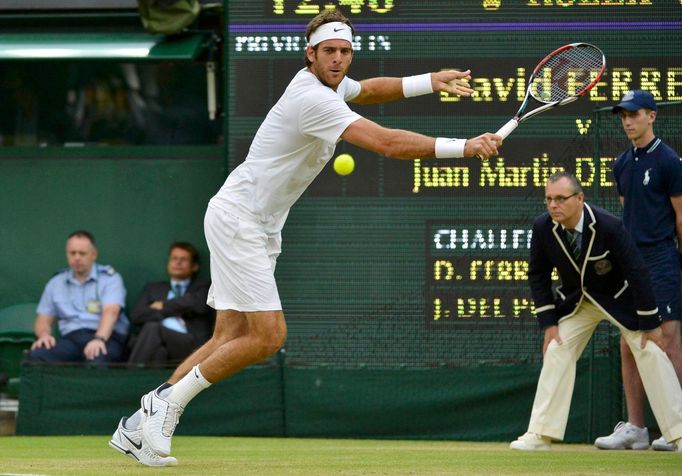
{"left": 141, "top": 207, "right": 286, "bottom": 456}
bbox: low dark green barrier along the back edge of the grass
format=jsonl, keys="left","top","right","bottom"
{"left": 17, "top": 358, "right": 620, "bottom": 443}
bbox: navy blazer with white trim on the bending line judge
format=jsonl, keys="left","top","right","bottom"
{"left": 528, "top": 203, "right": 660, "bottom": 330}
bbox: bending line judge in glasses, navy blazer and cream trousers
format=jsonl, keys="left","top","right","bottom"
{"left": 511, "top": 172, "right": 682, "bottom": 451}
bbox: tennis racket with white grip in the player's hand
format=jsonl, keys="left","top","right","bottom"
{"left": 497, "top": 43, "right": 606, "bottom": 139}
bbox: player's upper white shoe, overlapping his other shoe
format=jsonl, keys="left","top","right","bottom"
{"left": 141, "top": 390, "right": 184, "bottom": 456}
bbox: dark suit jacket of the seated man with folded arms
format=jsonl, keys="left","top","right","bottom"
{"left": 130, "top": 280, "right": 215, "bottom": 344}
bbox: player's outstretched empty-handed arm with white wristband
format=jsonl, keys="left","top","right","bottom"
{"left": 350, "top": 70, "right": 474, "bottom": 105}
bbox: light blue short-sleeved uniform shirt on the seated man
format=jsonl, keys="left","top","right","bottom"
{"left": 37, "top": 263, "right": 130, "bottom": 336}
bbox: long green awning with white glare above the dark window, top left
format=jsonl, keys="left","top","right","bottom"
{"left": 0, "top": 33, "right": 207, "bottom": 61}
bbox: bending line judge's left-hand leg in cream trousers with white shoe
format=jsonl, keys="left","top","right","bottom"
{"left": 511, "top": 303, "right": 603, "bottom": 450}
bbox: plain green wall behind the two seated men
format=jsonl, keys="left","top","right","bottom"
{"left": 0, "top": 151, "right": 225, "bottom": 307}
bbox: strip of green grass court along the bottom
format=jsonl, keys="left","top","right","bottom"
{"left": 0, "top": 436, "right": 682, "bottom": 476}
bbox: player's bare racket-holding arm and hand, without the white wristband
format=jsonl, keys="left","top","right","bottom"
{"left": 341, "top": 118, "right": 502, "bottom": 160}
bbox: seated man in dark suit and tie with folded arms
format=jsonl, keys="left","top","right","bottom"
{"left": 129, "top": 242, "right": 215, "bottom": 364}
